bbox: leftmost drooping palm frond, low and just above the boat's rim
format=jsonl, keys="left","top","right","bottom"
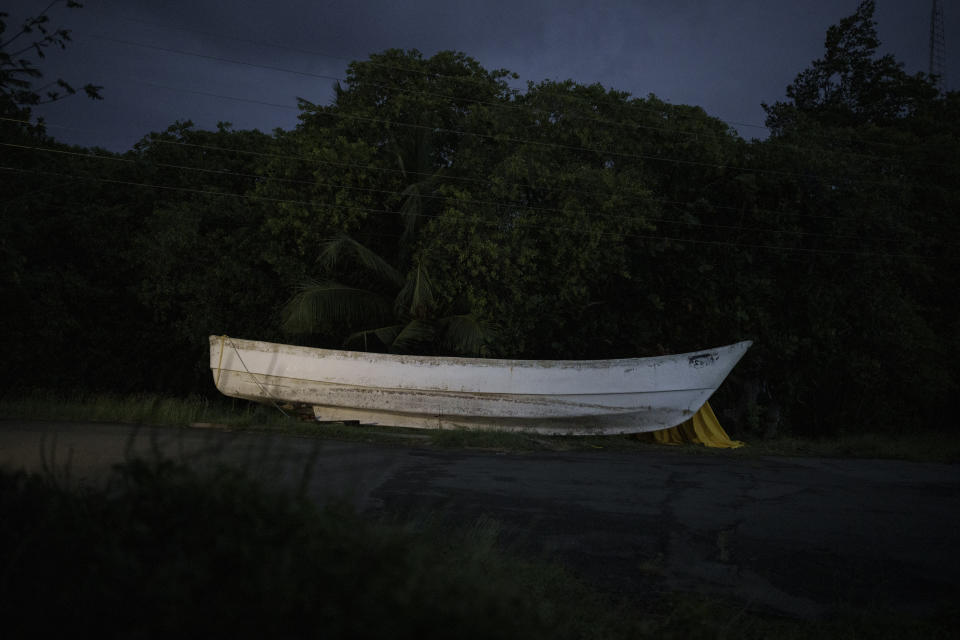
{"left": 283, "top": 280, "right": 392, "bottom": 334}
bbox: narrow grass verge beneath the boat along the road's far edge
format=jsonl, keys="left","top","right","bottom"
{"left": 0, "top": 393, "right": 960, "bottom": 462}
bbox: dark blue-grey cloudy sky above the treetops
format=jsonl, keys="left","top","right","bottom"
{"left": 4, "top": 0, "right": 960, "bottom": 151}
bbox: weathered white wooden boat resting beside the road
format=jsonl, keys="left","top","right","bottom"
{"left": 210, "top": 336, "right": 752, "bottom": 435}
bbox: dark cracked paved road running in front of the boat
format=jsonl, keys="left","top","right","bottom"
{"left": 0, "top": 421, "right": 960, "bottom": 617}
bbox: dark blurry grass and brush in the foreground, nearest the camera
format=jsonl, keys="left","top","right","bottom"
{"left": 0, "top": 459, "right": 958, "bottom": 640}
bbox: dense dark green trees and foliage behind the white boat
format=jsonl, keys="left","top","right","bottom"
{"left": 0, "top": 1, "right": 960, "bottom": 434}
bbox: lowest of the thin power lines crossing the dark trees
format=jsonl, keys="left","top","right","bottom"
{"left": 0, "top": 166, "right": 935, "bottom": 260}
